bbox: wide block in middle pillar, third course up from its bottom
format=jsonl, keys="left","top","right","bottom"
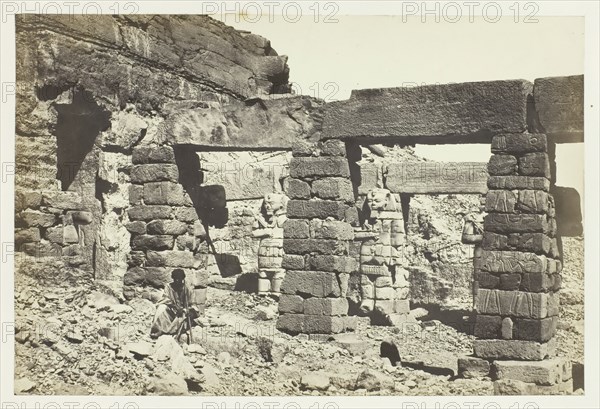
{"left": 281, "top": 270, "right": 341, "bottom": 298}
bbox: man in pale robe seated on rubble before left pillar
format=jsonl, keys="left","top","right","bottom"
{"left": 150, "top": 268, "right": 198, "bottom": 338}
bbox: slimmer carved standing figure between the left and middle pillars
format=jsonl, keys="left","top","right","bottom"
{"left": 252, "top": 193, "right": 288, "bottom": 296}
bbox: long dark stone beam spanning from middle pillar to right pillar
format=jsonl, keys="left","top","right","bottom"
{"left": 323, "top": 80, "right": 532, "bottom": 140}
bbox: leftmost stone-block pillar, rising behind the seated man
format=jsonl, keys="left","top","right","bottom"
{"left": 124, "top": 146, "right": 208, "bottom": 310}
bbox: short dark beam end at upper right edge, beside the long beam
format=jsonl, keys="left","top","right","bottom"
{"left": 533, "top": 75, "right": 584, "bottom": 142}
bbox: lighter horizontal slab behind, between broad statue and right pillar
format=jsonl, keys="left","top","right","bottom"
{"left": 386, "top": 162, "right": 488, "bottom": 194}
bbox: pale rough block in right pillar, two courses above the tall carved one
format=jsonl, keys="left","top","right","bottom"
{"left": 480, "top": 250, "right": 548, "bottom": 273}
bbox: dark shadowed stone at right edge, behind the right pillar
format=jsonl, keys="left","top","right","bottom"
{"left": 551, "top": 186, "right": 583, "bottom": 237}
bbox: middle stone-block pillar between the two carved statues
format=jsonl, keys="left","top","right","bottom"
{"left": 277, "top": 140, "right": 358, "bottom": 334}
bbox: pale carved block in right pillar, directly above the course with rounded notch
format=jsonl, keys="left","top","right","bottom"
{"left": 475, "top": 288, "right": 549, "bottom": 318}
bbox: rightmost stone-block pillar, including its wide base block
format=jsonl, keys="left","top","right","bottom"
{"left": 463, "top": 134, "right": 572, "bottom": 394}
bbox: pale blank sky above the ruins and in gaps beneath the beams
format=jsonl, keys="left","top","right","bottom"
{"left": 221, "top": 15, "right": 584, "bottom": 193}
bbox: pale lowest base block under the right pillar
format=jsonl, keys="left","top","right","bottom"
{"left": 493, "top": 358, "right": 572, "bottom": 385}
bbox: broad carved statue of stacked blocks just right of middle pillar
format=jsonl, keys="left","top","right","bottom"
{"left": 356, "top": 188, "right": 408, "bottom": 325}
